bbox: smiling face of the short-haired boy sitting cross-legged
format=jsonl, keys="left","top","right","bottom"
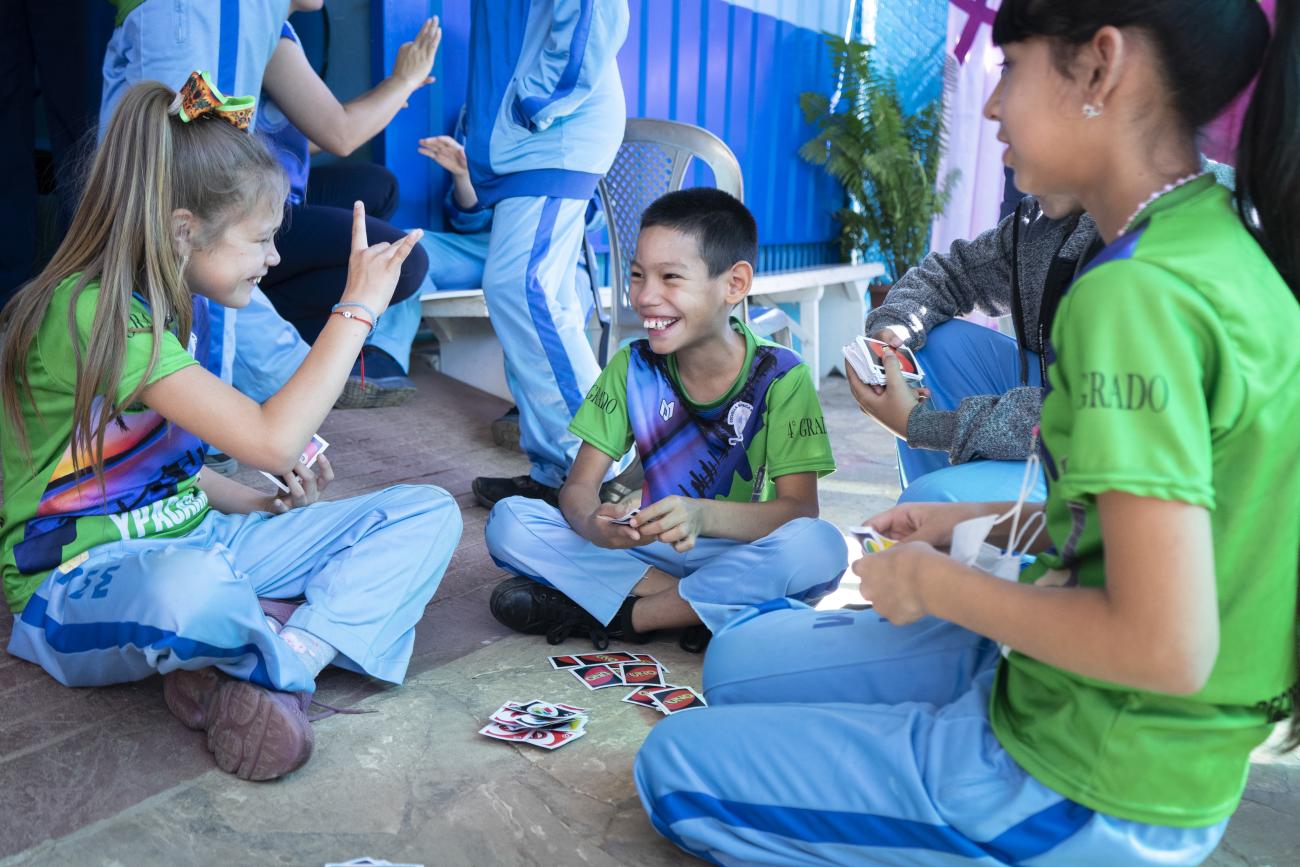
{"left": 631, "top": 226, "right": 754, "bottom": 359}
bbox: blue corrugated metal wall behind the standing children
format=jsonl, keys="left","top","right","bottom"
{"left": 372, "top": 0, "right": 846, "bottom": 261}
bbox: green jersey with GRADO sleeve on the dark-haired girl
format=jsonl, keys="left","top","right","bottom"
{"left": 989, "top": 177, "right": 1300, "bottom": 827}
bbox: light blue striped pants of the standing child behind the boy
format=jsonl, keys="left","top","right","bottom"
{"left": 484, "top": 196, "right": 601, "bottom": 487}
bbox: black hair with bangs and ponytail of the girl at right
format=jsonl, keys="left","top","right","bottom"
{"left": 993, "top": 0, "right": 1300, "bottom": 750}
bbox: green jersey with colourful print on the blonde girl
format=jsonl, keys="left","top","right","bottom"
{"left": 0, "top": 277, "right": 208, "bottom": 612}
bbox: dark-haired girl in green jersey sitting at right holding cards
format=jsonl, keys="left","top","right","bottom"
{"left": 636, "top": 0, "right": 1300, "bottom": 864}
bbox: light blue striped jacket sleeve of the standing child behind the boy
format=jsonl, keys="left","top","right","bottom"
{"left": 512, "top": 0, "right": 628, "bottom": 130}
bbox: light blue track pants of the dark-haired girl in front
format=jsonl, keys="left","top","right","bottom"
{"left": 633, "top": 601, "right": 1227, "bottom": 867}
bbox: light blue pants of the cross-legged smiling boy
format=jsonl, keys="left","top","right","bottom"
{"left": 485, "top": 497, "right": 848, "bottom": 632}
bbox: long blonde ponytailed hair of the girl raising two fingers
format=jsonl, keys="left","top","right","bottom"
{"left": 0, "top": 82, "right": 286, "bottom": 474}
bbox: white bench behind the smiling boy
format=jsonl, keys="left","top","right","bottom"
{"left": 420, "top": 263, "right": 884, "bottom": 400}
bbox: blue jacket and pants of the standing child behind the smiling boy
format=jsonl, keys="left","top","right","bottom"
{"left": 465, "top": 0, "right": 628, "bottom": 486}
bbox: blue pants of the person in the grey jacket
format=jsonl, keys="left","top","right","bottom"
{"left": 898, "top": 320, "right": 1047, "bottom": 503}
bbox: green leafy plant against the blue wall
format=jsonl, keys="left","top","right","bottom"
{"left": 800, "top": 34, "right": 958, "bottom": 305}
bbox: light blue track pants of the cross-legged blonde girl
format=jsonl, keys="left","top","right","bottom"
{"left": 9, "top": 485, "right": 460, "bottom": 690}
